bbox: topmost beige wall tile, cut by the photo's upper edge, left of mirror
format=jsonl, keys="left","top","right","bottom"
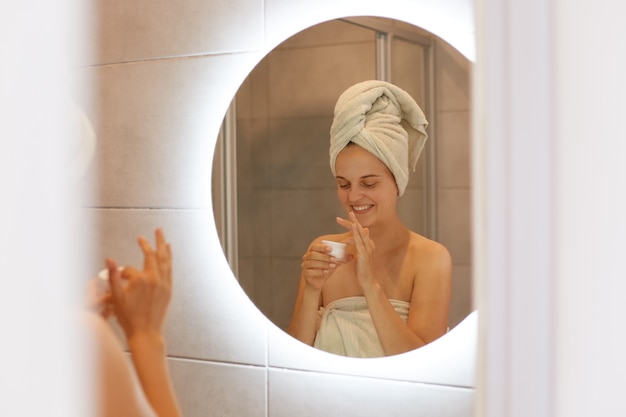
{"left": 95, "top": 0, "right": 264, "bottom": 64}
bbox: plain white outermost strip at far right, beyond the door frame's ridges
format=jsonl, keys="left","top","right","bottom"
{"left": 551, "top": 0, "right": 626, "bottom": 417}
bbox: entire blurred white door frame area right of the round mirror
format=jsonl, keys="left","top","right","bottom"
{"left": 475, "top": 0, "right": 626, "bottom": 417}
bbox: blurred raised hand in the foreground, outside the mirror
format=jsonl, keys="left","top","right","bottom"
{"left": 106, "top": 229, "right": 172, "bottom": 339}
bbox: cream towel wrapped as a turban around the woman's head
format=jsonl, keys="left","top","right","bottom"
{"left": 330, "top": 80, "right": 428, "bottom": 195}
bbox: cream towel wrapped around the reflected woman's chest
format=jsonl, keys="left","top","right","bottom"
{"left": 313, "top": 296, "right": 409, "bottom": 358}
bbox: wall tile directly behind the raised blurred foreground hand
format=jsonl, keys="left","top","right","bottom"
{"left": 84, "top": 209, "right": 267, "bottom": 365}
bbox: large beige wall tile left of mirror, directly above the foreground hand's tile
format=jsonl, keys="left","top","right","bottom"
{"left": 86, "top": 54, "right": 258, "bottom": 208}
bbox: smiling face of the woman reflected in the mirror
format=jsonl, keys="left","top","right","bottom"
{"left": 335, "top": 145, "right": 398, "bottom": 227}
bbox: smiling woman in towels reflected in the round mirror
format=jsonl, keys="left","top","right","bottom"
{"left": 288, "top": 81, "right": 451, "bottom": 357}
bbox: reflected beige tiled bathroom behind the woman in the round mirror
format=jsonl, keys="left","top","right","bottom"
{"left": 213, "top": 18, "right": 472, "bottom": 354}
